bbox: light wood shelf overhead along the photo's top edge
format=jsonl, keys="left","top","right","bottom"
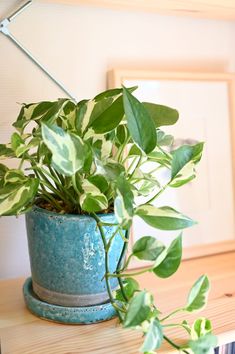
{"left": 38, "top": 0, "right": 235, "bottom": 20}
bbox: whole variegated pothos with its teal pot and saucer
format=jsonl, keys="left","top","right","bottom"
{"left": 0, "top": 87, "right": 216, "bottom": 354}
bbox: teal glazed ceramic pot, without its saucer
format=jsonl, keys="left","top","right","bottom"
{"left": 26, "top": 206, "right": 123, "bottom": 307}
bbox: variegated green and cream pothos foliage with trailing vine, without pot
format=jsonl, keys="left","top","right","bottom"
{"left": 0, "top": 87, "right": 216, "bottom": 354}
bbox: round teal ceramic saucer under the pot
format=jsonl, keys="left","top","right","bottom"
{"left": 23, "top": 278, "right": 116, "bottom": 324}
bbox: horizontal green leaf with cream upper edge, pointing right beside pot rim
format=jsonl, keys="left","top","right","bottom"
{"left": 136, "top": 205, "right": 195, "bottom": 230}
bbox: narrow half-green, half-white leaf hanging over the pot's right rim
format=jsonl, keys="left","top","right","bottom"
{"left": 114, "top": 176, "right": 134, "bottom": 227}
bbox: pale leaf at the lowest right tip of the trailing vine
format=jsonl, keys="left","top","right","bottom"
{"left": 189, "top": 334, "right": 217, "bottom": 354}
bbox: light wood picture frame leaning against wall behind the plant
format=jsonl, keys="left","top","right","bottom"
{"left": 108, "top": 70, "right": 235, "bottom": 258}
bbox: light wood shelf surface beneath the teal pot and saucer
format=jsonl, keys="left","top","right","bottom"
{"left": 0, "top": 252, "right": 235, "bottom": 354}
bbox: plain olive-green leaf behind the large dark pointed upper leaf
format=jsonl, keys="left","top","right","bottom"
{"left": 143, "top": 102, "right": 179, "bottom": 127}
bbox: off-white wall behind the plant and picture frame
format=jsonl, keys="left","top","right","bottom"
{"left": 0, "top": 0, "right": 235, "bottom": 278}
